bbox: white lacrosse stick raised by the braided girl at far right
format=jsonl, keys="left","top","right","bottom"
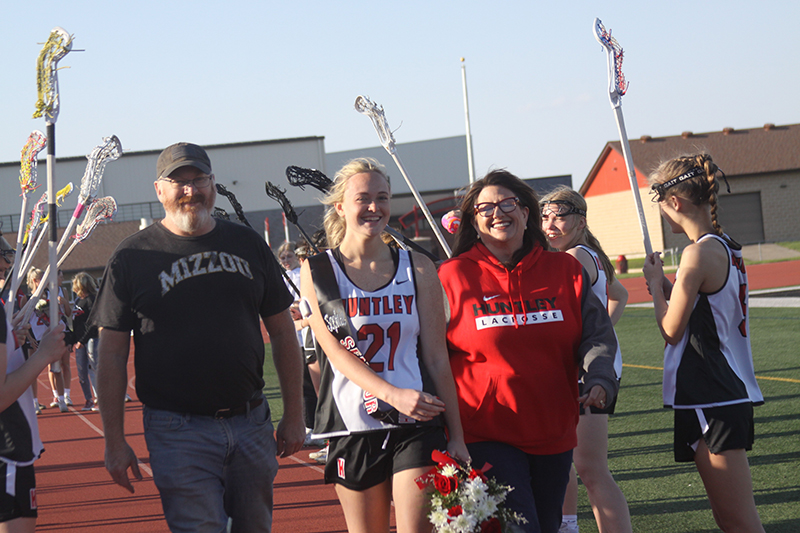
{"left": 592, "top": 18, "right": 653, "bottom": 255}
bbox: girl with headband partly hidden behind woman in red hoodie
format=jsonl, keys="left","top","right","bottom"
{"left": 541, "top": 186, "right": 631, "bottom": 533}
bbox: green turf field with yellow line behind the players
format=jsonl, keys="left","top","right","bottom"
{"left": 264, "top": 308, "right": 800, "bottom": 533}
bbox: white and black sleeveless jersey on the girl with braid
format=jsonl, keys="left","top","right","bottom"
{"left": 664, "top": 234, "right": 764, "bottom": 409}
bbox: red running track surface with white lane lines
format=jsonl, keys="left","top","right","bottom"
{"left": 31, "top": 261, "right": 800, "bottom": 533}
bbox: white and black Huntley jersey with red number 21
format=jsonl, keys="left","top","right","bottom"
{"left": 314, "top": 250, "right": 433, "bottom": 438}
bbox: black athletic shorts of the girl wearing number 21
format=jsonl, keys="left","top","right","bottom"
{"left": 325, "top": 426, "right": 447, "bottom": 490}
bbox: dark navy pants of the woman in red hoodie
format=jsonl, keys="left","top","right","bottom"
{"left": 467, "top": 442, "right": 572, "bottom": 533}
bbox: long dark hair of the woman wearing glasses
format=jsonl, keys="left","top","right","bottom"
{"left": 453, "top": 170, "right": 547, "bottom": 268}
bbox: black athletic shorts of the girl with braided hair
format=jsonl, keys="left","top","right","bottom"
{"left": 674, "top": 402, "right": 755, "bottom": 463}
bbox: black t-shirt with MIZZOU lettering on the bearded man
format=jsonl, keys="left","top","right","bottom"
{"left": 90, "top": 220, "right": 293, "bottom": 414}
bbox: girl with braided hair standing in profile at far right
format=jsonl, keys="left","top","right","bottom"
{"left": 644, "top": 154, "right": 764, "bottom": 532}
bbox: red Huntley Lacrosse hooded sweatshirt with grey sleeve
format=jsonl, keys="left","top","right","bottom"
{"left": 439, "top": 243, "right": 617, "bottom": 455}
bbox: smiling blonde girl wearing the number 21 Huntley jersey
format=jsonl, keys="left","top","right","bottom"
{"left": 300, "top": 159, "right": 469, "bottom": 533}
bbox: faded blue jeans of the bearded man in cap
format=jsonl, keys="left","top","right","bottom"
{"left": 144, "top": 399, "right": 278, "bottom": 533}
